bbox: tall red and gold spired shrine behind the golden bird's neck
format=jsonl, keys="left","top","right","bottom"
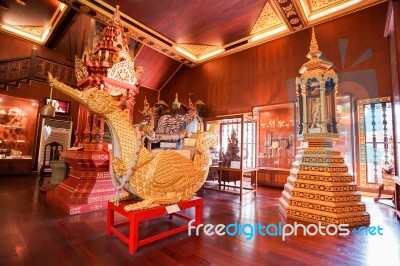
{"left": 47, "top": 7, "right": 142, "bottom": 214}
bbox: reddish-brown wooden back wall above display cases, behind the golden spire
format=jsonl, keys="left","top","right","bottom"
{"left": 160, "top": 3, "right": 391, "bottom": 117}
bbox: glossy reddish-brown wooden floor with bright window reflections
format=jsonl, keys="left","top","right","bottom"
{"left": 0, "top": 176, "right": 400, "bottom": 266}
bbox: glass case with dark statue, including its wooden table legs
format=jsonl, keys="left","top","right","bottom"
{"left": 204, "top": 114, "right": 258, "bottom": 200}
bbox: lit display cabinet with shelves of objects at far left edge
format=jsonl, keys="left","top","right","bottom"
{"left": 0, "top": 95, "right": 38, "bottom": 174}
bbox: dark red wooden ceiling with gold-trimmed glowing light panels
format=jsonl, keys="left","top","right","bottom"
{"left": 0, "top": 0, "right": 387, "bottom": 90}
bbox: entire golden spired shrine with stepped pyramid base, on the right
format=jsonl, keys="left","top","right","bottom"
{"left": 279, "top": 29, "right": 370, "bottom": 226}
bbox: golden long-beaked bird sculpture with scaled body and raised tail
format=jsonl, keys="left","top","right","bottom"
{"left": 48, "top": 73, "right": 219, "bottom": 211}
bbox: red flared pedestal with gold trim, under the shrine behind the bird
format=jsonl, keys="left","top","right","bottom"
{"left": 47, "top": 143, "right": 115, "bottom": 215}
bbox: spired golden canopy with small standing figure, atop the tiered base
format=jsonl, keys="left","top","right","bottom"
{"left": 296, "top": 28, "right": 338, "bottom": 135}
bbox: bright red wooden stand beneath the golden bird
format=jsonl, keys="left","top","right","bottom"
{"left": 107, "top": 197, "right": 203, "bottom": 254}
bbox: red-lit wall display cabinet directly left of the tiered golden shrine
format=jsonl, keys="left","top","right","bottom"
{"left": 253, "top": 102, "right": 298, "bottom": 187}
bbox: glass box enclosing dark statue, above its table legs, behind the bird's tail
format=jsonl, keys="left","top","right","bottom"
{"left": 204, "top": 114, "right": 257, "bottom": 169}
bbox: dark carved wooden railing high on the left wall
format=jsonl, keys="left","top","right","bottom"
{"left": 0, "top": 49, "right": 76, "bottom": 90}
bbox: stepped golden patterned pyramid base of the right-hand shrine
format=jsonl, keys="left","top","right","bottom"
{"left": 279, "top": 133, "right": 370, "bottom": 226}
